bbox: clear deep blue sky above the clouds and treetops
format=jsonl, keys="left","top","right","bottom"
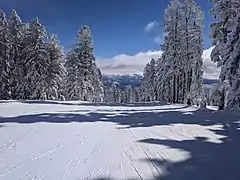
{"left": 0, "top": 0, "right": 212, "bottom": 58}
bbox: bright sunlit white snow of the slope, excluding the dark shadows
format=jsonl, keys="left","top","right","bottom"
{"left": 0, "top": 102, "right": 232, "bottom": 180}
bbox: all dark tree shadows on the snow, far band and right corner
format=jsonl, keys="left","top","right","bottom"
{"left": 0, "top": 106, "right": 240, "bottom": 180}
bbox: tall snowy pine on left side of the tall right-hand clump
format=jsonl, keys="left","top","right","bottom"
{"left": 162, "top": 0, "right": 183, "bottom": 103}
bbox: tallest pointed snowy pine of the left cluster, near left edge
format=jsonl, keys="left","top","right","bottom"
{"left": 8, "top": 10, "right": 26, "bottom": 99}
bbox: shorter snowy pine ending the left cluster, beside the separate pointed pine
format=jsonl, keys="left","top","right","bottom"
{"left": 46, "top": 35, "right": 65, "bottom": 100}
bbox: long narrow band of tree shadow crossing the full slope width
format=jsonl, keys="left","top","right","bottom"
{"left": 0, "top": 107, "right": 240, "bottom": 128}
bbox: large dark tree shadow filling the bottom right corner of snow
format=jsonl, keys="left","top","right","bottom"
{"left": 140, "top": 113, "right": 240, "bottom": 180}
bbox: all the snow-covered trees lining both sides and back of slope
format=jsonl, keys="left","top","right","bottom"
{"left": 0, "top": 0, "right": 240, "bottom": 110}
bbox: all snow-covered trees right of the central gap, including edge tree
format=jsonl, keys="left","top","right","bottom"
{"left": 141, "top": 0, "right": 240, "bottom": 110}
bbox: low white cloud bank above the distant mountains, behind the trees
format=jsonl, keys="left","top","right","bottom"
{"left": 97, "top": 48, "right": 220, "bottom": 79}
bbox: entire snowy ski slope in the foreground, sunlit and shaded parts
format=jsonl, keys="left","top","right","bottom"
{"left": 0, "top": 101, "right": 240, "bottom": 180}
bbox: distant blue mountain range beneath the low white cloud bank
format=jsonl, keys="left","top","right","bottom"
{"left": 103, "top": 74, "right": 219, "bottom": 89}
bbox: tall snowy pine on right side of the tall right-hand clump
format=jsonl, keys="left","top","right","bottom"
{"left": 182, "top": 0, "right": 205, "bottom": 105}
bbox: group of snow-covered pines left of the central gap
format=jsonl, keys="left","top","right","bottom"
{"left": 0, "top": 10, "right": 104, "bottom": 101}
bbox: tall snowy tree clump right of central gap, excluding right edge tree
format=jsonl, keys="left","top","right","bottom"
{"left": 141, "top": 0, "right": 205, "bottom": 105}
